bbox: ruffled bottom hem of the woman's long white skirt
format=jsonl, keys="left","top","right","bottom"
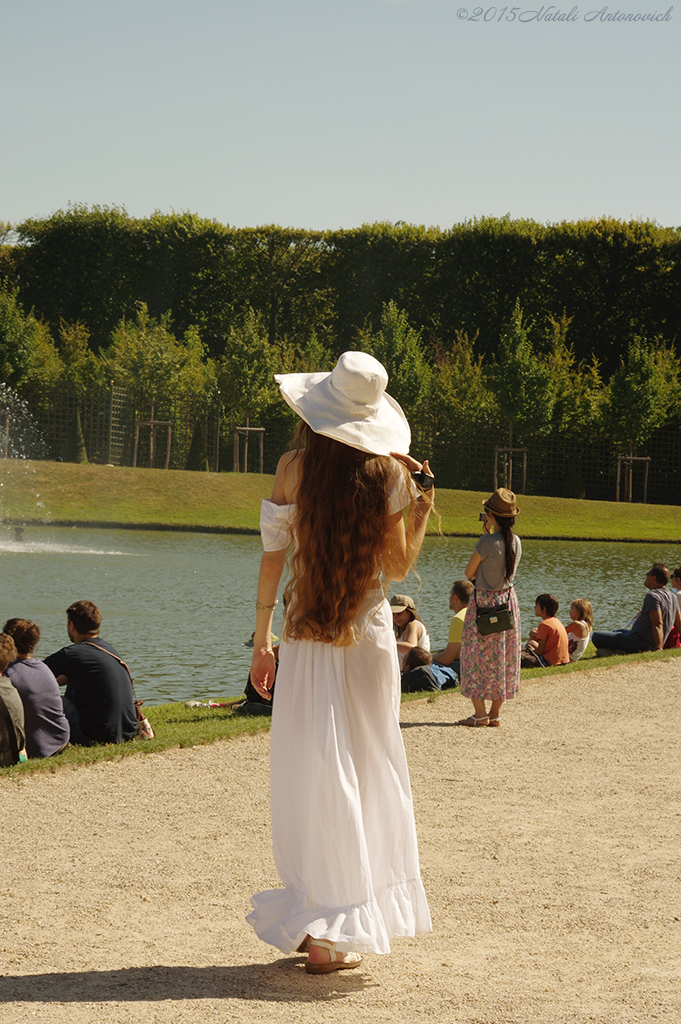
{"left": 246, "top": 879, "right": 432, "bottom": 953}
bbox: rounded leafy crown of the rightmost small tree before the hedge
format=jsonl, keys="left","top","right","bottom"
{"left": 605, "top": 336, "right": 680, "bottom": 455}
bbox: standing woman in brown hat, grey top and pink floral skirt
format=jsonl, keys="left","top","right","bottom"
{"left": 457, "top": 487, "right": 522, "bottom": 726}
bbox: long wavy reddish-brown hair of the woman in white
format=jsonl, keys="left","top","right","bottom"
{"left": 284, "top": 422, "right": 409, "bottom": 647}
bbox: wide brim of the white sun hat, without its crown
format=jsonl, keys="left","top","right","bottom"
{"left": 274, "top": 360, "right": 412, "bottom": 455}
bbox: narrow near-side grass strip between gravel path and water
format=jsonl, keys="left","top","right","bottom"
{"left": 0, "top": 645, "right": 681, "bottom": 779}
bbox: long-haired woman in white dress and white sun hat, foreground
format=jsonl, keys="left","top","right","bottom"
{"left": 248, "top": 352, "right": 433, "bottom": 974}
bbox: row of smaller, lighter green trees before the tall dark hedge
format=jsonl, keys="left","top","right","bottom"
{"left": 0, "top": 287, "right": 681, "bottom": 466}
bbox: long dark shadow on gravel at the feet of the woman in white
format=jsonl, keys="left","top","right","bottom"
{"left": 0, "top": 958, "right": 372, "bottom": 1002}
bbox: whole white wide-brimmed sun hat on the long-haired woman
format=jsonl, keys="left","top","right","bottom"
{"left": 274, "top": 352, "right": 412, "bottom": 455}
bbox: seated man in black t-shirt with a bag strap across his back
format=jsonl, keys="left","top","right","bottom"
{"left": 45, "top": 601, "right": 137, "bottom": 746}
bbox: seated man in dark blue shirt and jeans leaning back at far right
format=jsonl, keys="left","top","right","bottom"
{"left": 591, "top": 562, "right": 681, "bottom": 657}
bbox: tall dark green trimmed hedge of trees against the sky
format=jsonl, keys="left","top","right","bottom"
{"left": 0, "top": 206, "right": 681, "bottom": 378}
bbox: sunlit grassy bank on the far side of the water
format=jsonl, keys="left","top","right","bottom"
{"left": 0, "top": 460, "right": 681, "bottom": 544}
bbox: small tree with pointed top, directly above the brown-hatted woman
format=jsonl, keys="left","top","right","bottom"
{"left": 488, "top": 302, "right": 555, "bottom": 446}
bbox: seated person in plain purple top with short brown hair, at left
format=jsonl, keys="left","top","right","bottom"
{"left": 3, "top": 618, "right": 70, "bottom": 758}
